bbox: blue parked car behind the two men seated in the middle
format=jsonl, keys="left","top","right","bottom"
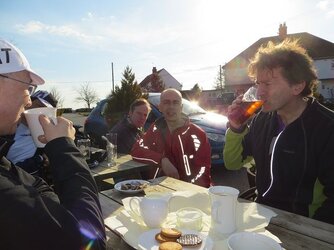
{"left": 84, "top": 93, "right": 228, "bottom": 165}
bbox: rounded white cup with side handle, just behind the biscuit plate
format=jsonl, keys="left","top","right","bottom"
{"left": 129, "top": 196, "right": 168, "bottom": 228}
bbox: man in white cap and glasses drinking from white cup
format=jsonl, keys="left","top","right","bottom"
{"left": 0, "top": 39, "right": 105, "bottom": 249}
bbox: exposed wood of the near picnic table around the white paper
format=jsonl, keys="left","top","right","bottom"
{"left": 100, "top": 177, "right": 334, "bottom": 250}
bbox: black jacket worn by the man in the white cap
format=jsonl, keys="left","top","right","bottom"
{"left": 0, "top": 137, "right": 106, "bottom": 250}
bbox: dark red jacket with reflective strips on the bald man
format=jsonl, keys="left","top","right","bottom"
{"left": 131, "top": 117, "right": 211, "bottom": 187}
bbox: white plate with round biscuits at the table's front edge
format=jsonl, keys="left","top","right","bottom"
{"left": 138, "top": 228, "right": 213, "bottom": 250}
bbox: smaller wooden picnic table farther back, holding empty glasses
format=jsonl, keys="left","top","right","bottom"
{"left": 91, "top": 154, "right": 154, "bottom": 190}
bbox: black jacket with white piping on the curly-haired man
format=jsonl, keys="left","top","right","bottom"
{"left": 224, "top": 98, "right": 334, "bottom": 224}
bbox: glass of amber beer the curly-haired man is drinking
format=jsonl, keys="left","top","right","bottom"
{"left": 228, "top": 86, "right": 263, "bottom": 125}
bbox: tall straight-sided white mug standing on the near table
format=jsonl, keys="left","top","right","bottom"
{"left": 209, "top": 186, "right": 239, "bottom": 234}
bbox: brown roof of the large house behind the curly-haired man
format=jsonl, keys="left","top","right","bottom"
{"left": 223, "top": 32, "right": 334, "bottom": 68}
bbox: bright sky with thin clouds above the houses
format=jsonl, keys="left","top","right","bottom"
{"left": 0, "top": 0, "right": 334, "bottom": 109}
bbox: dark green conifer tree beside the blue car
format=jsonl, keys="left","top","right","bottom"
{"left": 103, "top": 66, "right": 147, "bottom": 127}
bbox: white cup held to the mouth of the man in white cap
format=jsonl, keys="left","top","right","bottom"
{"left": 24, "top": 107, "right": 57, "bottom": 148}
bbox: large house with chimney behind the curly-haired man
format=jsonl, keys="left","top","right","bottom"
{"left": 223, "top": 23, "right": 334, "bottom": 101}
